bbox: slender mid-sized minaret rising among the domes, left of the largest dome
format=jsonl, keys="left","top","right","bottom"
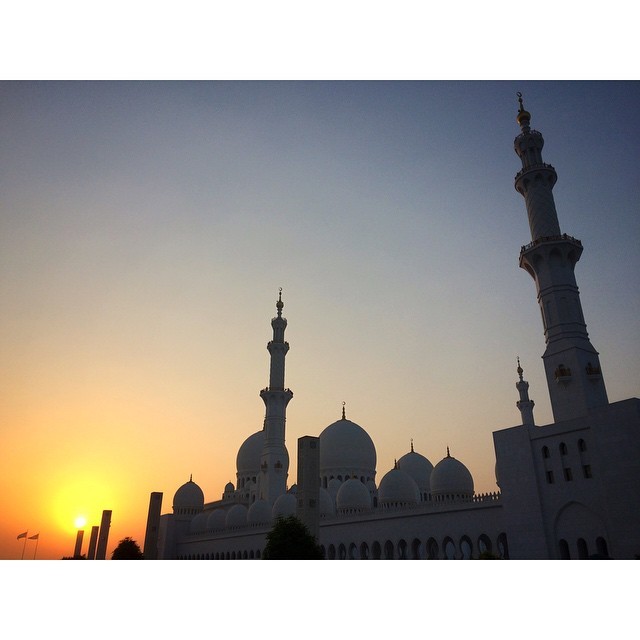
{"left": 258, "top": 289, "right": 293, "bottom": 503}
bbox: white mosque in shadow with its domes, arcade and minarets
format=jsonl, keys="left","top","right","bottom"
{"left": 144, "top": 94, "right": 640, "bottom": 560}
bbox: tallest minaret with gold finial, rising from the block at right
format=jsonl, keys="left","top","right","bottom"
{"left": 514, "top": 92, "right": 608, "bottom": 422}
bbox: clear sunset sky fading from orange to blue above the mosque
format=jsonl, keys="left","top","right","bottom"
{"left": 0, "top": 81, "right": 640, "bottom": 559}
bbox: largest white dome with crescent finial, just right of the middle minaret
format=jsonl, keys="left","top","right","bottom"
{"left": 320, "top": 418, "right": 376, "bottom": 482}
